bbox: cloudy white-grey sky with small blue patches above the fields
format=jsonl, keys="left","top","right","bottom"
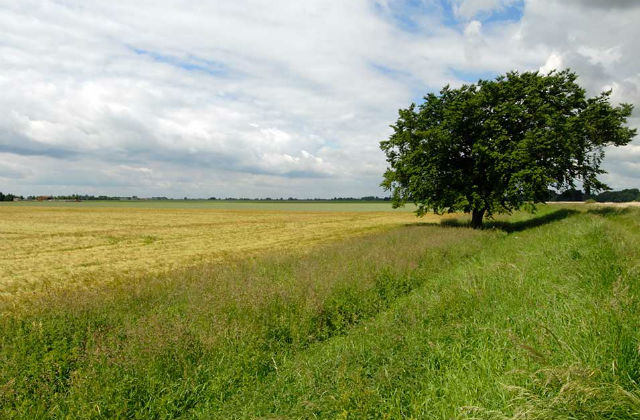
{"left": 0, "top": 0, "right": 640, "bottom": 198}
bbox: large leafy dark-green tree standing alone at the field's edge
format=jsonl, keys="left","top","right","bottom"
{"left": 380, "top": 70, "right": 636, "bottom": 228}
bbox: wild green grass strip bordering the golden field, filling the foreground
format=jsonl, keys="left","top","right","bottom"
{"left": 0, "top": 207, "right": 640, "bottom": 419}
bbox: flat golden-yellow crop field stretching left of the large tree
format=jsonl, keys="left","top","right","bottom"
{"left": 0, "top": 204, "right": 437, "bottom": 303}
